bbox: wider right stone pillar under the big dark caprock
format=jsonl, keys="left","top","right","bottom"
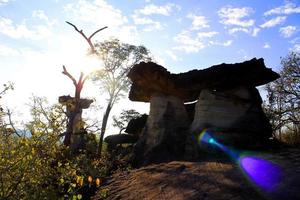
{"left": 191, "top": 87, "right": 272, "bottom": 147}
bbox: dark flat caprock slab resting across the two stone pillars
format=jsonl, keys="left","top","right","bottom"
{"left": 128, "top": 58, "right": 279, "bottom": 102}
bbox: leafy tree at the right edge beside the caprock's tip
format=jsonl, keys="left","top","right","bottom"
{"left": 265, "top": 52, "right": 300, "bottom": 142}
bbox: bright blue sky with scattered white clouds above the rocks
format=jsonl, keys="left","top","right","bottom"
{"left": 0, "top": 0, "right": 300, "bottom": 131}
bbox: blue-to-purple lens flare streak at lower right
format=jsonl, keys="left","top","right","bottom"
{"left": 198, "top": 129, "right": 283, "bottom": 191}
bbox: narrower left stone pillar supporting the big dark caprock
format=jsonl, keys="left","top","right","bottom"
{"left": 135, "top": 95, "right": 190, "bottom": 164}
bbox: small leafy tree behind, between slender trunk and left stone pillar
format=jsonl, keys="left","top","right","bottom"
{"left": 112, "top": 109, "right": 141, "bottom": 134}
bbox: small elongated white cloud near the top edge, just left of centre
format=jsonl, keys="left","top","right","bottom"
{"left": 135, "top": 3, "right": 181, "bottom": 16}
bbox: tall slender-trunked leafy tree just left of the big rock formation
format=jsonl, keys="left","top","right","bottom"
{"left": 92, "top": 39, "right": 151, "bottom": 154}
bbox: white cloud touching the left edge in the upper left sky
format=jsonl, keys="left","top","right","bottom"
{"left": 0, "top": 17, "right": 52, "bottom": 40}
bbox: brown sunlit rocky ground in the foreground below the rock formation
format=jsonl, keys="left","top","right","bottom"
{"left": 94, "top": 148, "right": 300, "bottom": 200}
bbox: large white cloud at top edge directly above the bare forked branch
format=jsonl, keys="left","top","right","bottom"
{"left": 64, "top": 0, "right": 128, "bottom": 28}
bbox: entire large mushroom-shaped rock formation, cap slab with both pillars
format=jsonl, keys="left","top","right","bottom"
{"left": 128, "top": 58, "right": 279, "bottom": 163}
